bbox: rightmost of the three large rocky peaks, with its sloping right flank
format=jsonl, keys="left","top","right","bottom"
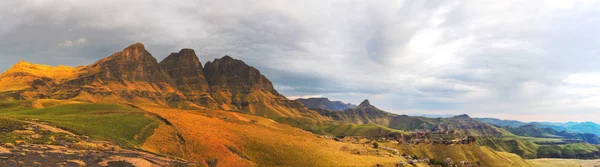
{"left": 203, "top": 56, "right": 320, "bottom": 118}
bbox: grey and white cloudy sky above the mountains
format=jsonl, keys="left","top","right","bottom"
{"left": 0, "top": 0, "right": 600, "bottom": 122}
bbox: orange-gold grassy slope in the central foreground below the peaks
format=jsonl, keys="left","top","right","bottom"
{"left": 143, "top": 107, "right": 400, "bottom": 166}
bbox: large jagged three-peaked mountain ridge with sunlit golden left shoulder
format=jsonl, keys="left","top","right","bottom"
{"left": 0, "top": 43, "right": 321, "bottom": 119}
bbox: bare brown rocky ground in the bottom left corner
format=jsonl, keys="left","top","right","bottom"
{"left": 0, "top": 122, "right": 187, "bottom": 167}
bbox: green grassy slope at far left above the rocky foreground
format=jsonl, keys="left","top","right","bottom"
{"left": 0, "top": 101, "right": 159, "bottom": 147}
